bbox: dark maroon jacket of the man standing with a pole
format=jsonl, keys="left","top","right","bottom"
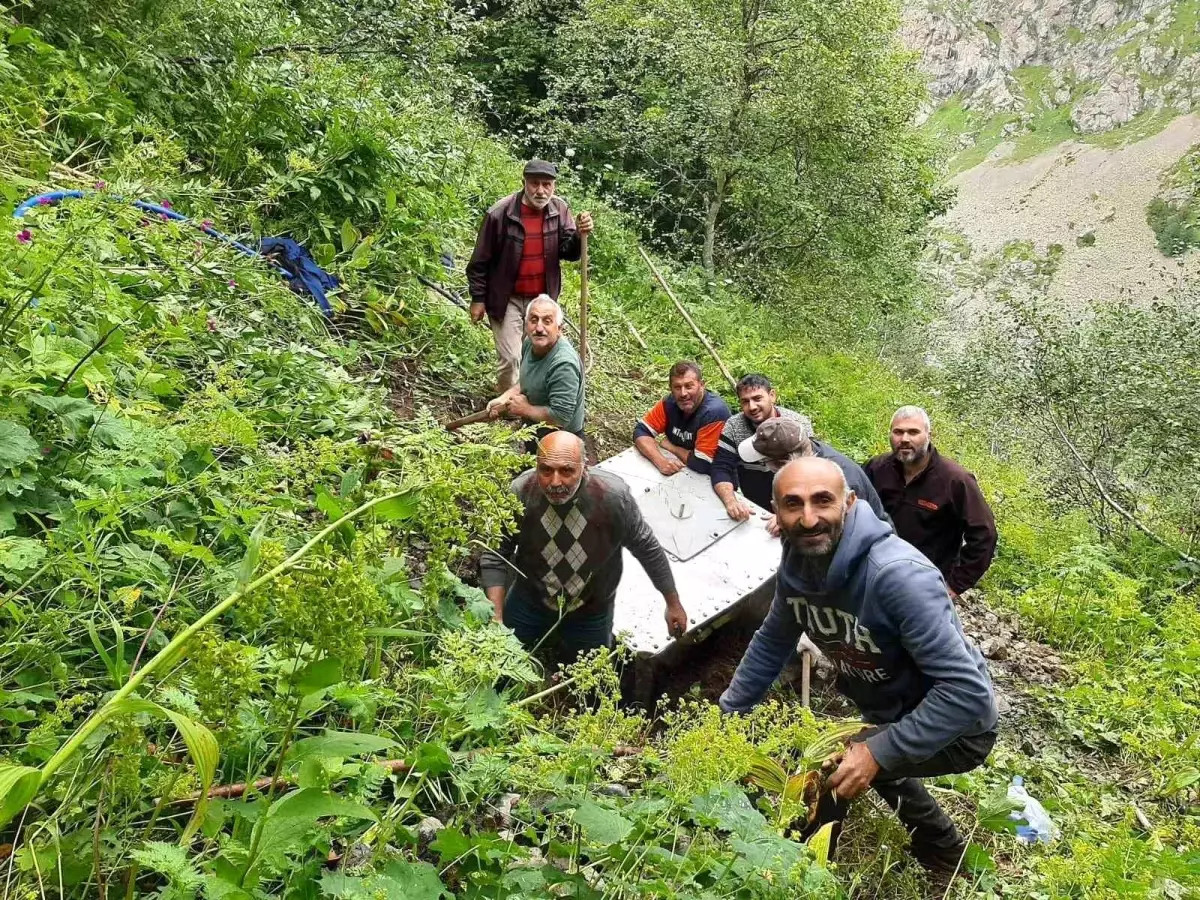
{"left": 467, "top": 191, "right": 580, "bottom": 322}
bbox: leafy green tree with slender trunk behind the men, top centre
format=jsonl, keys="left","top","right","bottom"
{"left": 544, "top": 0, "right": 935, "bottom": 283}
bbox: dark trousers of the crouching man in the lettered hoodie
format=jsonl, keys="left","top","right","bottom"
{"left": 805, "top": 725, "right": 996, "bottom": 866}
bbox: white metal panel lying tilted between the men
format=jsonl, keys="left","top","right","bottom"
{"left": 598, "top": 448, "right": 780, "bottom": 655}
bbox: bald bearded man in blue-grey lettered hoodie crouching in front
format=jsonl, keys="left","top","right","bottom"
{"left": 720, "top": 457, "right": 997, "bottom": 874}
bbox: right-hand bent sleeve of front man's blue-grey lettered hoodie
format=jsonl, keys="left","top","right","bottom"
{"left": 865, "top": 560, "right": 996, "bottom": 769}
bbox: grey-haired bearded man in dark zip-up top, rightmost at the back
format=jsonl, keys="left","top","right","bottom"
{"left": 863, "top": 407, "right": 996, "bottom": 600}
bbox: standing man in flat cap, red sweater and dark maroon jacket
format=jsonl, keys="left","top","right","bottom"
{"left": 467, "top": 160, "right": 593, "bottom": 394}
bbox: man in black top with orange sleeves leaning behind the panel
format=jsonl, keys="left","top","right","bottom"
{"left": 634, "top": 360, "right": 730, "bottom": 475}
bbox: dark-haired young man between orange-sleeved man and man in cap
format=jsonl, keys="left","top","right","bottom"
{"left": 710, "top": 374, "right": 812, "bottom": 522}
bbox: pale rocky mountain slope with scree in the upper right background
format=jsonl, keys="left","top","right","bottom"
{"left": 901, "top": 0, "right": 1200, "bottom": 336}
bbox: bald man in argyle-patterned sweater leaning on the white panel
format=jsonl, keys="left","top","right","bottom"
{"left": 480, "top": 431, "right": 688, "bottom": 662}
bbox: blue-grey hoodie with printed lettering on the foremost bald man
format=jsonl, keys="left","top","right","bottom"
{"left": 720, "top": 503, "right": 998, "bottom": 769}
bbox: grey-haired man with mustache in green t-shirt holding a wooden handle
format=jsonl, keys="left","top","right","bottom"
{"left": 487, "top": 294, "right": 583, "bottom": 437}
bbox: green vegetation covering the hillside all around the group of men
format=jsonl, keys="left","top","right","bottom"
{"left": 0, "top": 0, "right": 1200, "bottom": 900}
